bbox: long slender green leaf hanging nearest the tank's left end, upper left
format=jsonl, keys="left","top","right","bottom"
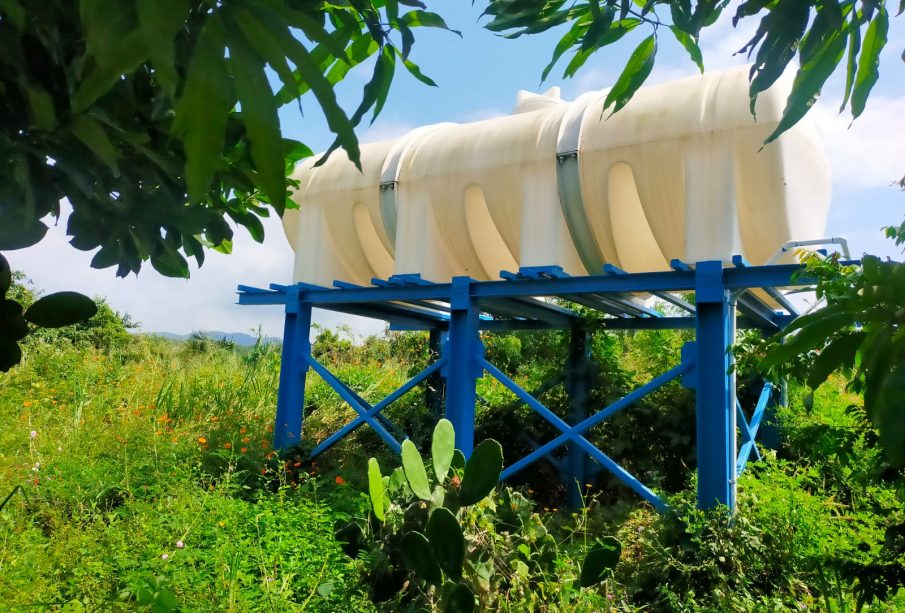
{"left": 229, "top": 26, "right": 286, "bottom": 211}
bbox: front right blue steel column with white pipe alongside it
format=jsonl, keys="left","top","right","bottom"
{"left": 695, "top": 261, "right": 736, "bottom": 510}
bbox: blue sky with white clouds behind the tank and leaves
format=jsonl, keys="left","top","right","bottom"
{"left": 7, "top": 0, "right": 905, "bottom": 336}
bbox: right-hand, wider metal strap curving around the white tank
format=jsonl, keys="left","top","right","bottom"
{"left": 556, "top": 96, "right": 603, "bottom": 274}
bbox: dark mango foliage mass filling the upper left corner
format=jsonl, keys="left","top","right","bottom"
{"left": 0, "top": 0, "right": 446, "bottom": 370}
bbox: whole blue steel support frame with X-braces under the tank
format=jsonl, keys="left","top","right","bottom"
{"left": 239, "top": 258, "right": 832, "bottom": 509}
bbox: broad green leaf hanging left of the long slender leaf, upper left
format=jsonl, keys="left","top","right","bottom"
{"left": 172, "top": 17, "right": 233, "bottom": 202}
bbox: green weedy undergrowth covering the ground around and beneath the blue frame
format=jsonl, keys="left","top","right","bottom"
{"left": 0, "top": 280, "right": 905, "bottom": 612}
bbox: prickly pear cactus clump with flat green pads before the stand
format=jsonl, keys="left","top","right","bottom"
{"left": 354, "top": 420, "right": 621, "bottom": 613}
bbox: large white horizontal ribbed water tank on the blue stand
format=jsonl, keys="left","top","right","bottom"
{"left": 284, "top": 68, "right": 830, "bottom": 286}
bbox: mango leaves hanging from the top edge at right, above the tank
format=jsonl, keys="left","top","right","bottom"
{"left": 484, "top": 0, "right": 905, "bottom": 142}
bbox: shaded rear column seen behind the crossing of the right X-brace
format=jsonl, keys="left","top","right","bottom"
{"left": 565, "top": 326, "right": 592, "bottom": 509}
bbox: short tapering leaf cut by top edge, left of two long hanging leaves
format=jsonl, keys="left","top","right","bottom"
{"left": 135, "top": 0, "right": 189, "bottom": 98}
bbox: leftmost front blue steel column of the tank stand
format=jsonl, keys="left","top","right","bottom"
{"left": 273, "top": 286, "right": 311, "bottom": 449}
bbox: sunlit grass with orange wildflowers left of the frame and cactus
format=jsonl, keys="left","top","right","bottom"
{"left": 0, "top": 340, "right": 368, "bottom": 611}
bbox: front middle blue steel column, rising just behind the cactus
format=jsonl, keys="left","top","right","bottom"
{"left": 446, "top": 277, "right": 481, "bottom": 458}
